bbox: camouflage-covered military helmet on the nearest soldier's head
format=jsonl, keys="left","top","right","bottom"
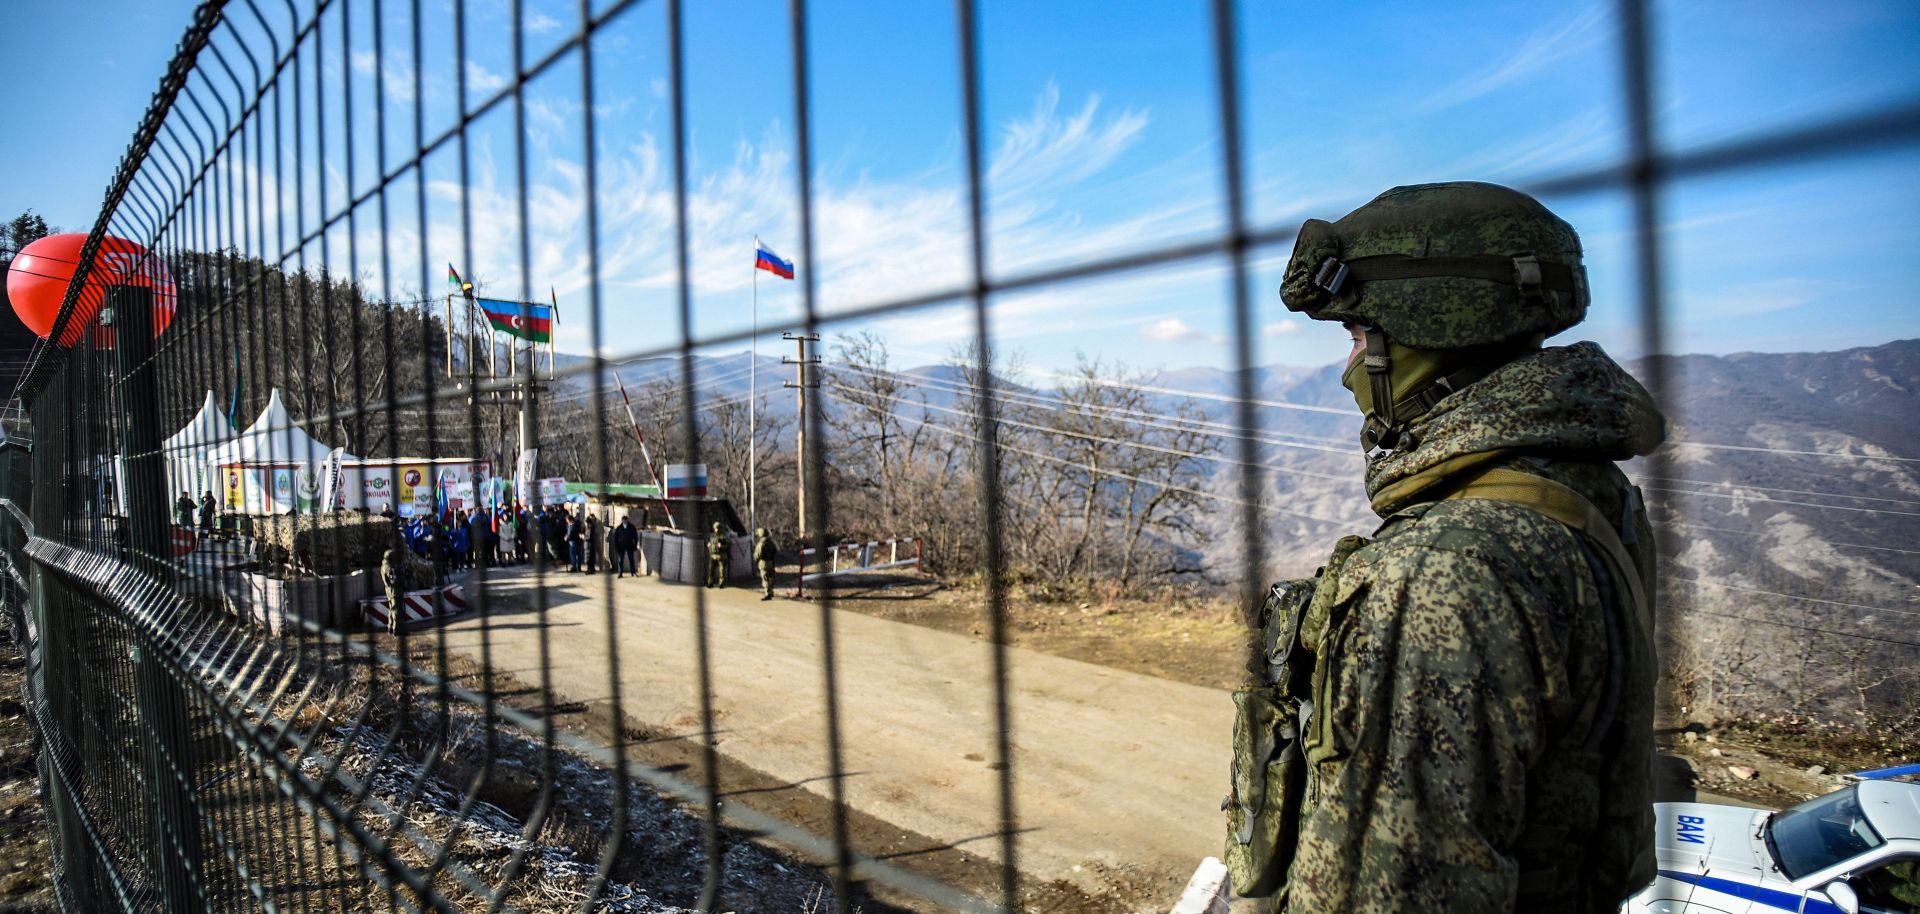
{"left": 1281, "top": 180, "right": 1588, "bottom": 349}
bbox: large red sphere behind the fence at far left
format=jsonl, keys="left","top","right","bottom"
{"left": 6, "top": 232, "right": 175, "bottom": 348}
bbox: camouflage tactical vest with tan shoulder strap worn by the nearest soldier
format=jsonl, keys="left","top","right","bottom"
{"left": 1221, "top": 461, "right": 1653, "bottom": 910}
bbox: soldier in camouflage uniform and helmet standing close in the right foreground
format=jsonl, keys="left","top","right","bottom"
{"left": 1227, "top": 182, "right": 1665, "bottom": 914}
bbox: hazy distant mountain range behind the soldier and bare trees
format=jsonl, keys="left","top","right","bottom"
{"left": 561, "top": 340, "right": 1920, "bottom": 637}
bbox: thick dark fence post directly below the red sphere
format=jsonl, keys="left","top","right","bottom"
{"left": 102, "top": 286, "right": 207, "bottom": 914}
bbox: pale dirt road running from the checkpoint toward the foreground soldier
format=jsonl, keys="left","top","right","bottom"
{"left": 435, "top": 568, "right": 1233, "bottom": 902}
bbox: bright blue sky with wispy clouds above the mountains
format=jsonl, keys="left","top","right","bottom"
{"left": 0, "top": 0, "right": 1920, "bottom": 369}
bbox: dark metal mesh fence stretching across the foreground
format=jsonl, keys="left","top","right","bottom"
{"left": 0, "top": 0, "right": 1920, "bottom": 910}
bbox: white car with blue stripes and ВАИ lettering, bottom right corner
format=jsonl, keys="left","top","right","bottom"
{"left": 1622, "top": 764, "right": 1920, "bottom": 914}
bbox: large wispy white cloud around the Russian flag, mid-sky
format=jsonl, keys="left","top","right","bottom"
{"left": 339, "top": 83, "right": 1159, "bottom": 351}
